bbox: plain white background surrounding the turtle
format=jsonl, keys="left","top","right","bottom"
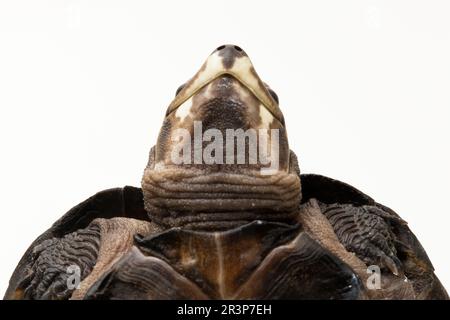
{"left": 0, "top": 0, "right": 450, "bottom": 294}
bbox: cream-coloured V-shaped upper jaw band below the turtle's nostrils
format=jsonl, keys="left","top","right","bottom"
{"left": 167, "top": 51, "right": 283, "bottom": 121}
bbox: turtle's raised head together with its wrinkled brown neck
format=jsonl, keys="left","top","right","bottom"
{"left": 142, "top": 45, "right": 301, "bottom": 229}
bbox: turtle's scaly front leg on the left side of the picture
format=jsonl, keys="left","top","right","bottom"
{"left": 5, "top": 218, "right": 159, "bottom": 300}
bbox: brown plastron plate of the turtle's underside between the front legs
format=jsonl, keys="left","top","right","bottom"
{"left": 86, "top": 221, "right": 362, "bottom": 299}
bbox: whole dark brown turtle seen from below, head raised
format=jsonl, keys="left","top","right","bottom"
{"left": 5, "top": 45, "right": 448, "bottom": 300}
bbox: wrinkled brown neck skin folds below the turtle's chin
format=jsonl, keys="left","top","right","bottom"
{"left": 142, "top": 148, "right": 301, "bottom": 231}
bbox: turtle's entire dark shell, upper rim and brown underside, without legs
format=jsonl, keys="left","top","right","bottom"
{"left": 5, "top": 175, "right": 448, "bottom": 299}
